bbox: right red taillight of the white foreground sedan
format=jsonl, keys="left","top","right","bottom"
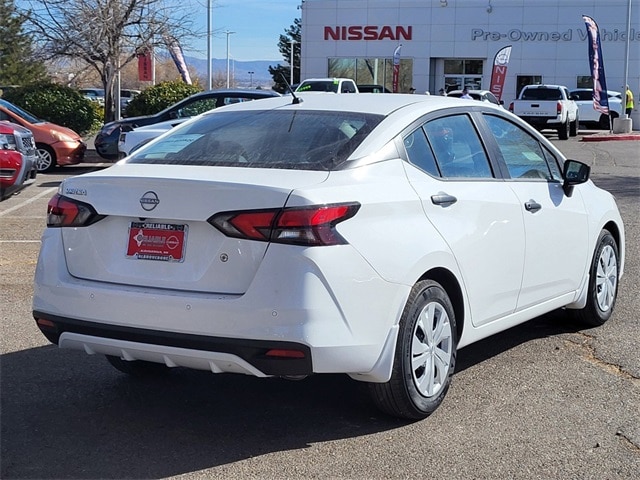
{"left": 208, "top": 203, "right": 360, "bottom": 246}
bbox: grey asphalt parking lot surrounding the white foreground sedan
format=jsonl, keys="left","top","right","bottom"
{"left": 0, "top": 132, "right": 640, "bottom": 480}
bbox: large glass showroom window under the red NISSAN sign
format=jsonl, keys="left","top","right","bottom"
{"left": 327, "top": 58, "right": 413, "bottom": 93}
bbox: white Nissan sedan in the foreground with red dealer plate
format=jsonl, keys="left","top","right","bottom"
{"left": 33, "top": 93, "right": 624, "bottom": 419}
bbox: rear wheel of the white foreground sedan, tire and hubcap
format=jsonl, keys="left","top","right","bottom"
{"left": 369, "top": 280, "right": 457, "bottom": 420}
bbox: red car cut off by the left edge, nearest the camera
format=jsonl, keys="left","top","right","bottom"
{"left": 0, "top": 121, "right": 37, "bottom": 200}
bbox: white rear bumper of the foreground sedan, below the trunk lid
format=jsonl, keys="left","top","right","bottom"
{"left": 33, "top": 229, "right": 410, "bottom": 381}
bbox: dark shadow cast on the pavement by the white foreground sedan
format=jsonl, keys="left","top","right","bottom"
{"left": 0, "top": 312, "right": 576, "bottom": 479}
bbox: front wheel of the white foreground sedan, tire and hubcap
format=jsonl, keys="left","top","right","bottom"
{"left": 573, "top": 230, "right": 620, "bottom": 327}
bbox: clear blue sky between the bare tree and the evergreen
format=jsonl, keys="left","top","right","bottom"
{"left": 184, "top": 0, "right": 302, "bottom": 61}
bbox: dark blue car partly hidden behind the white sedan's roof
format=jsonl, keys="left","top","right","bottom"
{"left": 95, "top": 90, "right": 279, "bottom": 160}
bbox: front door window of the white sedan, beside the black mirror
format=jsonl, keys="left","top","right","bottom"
{"left": 484, "top": 115, "right": 561, "bottom": 181}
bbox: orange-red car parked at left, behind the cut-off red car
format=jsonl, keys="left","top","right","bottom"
{"left": 0, "top": 99, "right": 87, "bottom": 172}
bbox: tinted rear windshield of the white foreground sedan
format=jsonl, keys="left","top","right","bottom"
{"left": 127, "top": 110, "right": 383, "bottom": 170}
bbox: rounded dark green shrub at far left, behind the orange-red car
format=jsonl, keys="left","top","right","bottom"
{"left": 3, "top": 82, "right": 102, "bottom": 135}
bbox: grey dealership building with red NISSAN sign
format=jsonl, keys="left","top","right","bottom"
{"left": 301, "top": 0, "right": 640, "bottom": 113}
